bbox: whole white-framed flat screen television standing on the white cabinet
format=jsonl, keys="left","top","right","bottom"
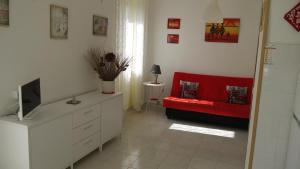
{"left": 18, "top": 79, "right": 41, "bottom": 120}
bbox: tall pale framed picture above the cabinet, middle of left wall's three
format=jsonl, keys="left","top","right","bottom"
{"left": 50, "top": 5, "right": 68, "bottom": 39}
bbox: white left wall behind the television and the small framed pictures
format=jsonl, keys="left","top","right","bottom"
{"left": 0, "top": 0, "right": 115, "bottom": 115}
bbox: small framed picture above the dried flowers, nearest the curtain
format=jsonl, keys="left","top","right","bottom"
{"left": 93, "top": 15, "right": 108, "bottom": 36}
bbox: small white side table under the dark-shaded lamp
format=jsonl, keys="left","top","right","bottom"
{"left": 143, "top": 82, "right": 165, "bottom": 110}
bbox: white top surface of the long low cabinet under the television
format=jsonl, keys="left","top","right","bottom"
{"left": 0, "top": 91, "right": 122, "bottom": 128}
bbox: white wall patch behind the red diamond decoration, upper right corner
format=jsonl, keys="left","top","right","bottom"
{"left": 269, "top": 0, "right": 300, "bottom": 44}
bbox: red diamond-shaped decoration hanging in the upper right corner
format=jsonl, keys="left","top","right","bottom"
{"left": 284, "top": 2, "right": 300, "bottom": 32}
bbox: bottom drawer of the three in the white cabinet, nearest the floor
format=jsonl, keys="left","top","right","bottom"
{"left": 73, "top": 132, "right": 100, "bottom": 162}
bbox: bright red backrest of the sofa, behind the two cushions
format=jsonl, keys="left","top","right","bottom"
{"left": 171, "top": 72, "right": 253, "bottom": 104}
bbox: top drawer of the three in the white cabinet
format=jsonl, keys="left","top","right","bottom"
{"left": 73, "top": 105, "right": 100, "bottom": 128}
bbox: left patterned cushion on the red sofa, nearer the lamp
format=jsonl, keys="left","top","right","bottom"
{"left": 180, "top": 80, "right": 199, "bottom": 99}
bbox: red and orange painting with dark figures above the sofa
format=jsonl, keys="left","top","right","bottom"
{"left": 205, "top": 18, "right": 240, "bottom": 43}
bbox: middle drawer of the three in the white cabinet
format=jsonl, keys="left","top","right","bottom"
{"left": 73, "top": 118, "right": 100, "bottom": 144}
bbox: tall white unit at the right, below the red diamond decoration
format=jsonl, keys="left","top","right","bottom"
{"left": 253, "top": 43, "right": 300, "bottom": 169}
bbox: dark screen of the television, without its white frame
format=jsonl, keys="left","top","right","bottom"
{"left": 21, "top": 79, "right": 41, "bottom": 117}
